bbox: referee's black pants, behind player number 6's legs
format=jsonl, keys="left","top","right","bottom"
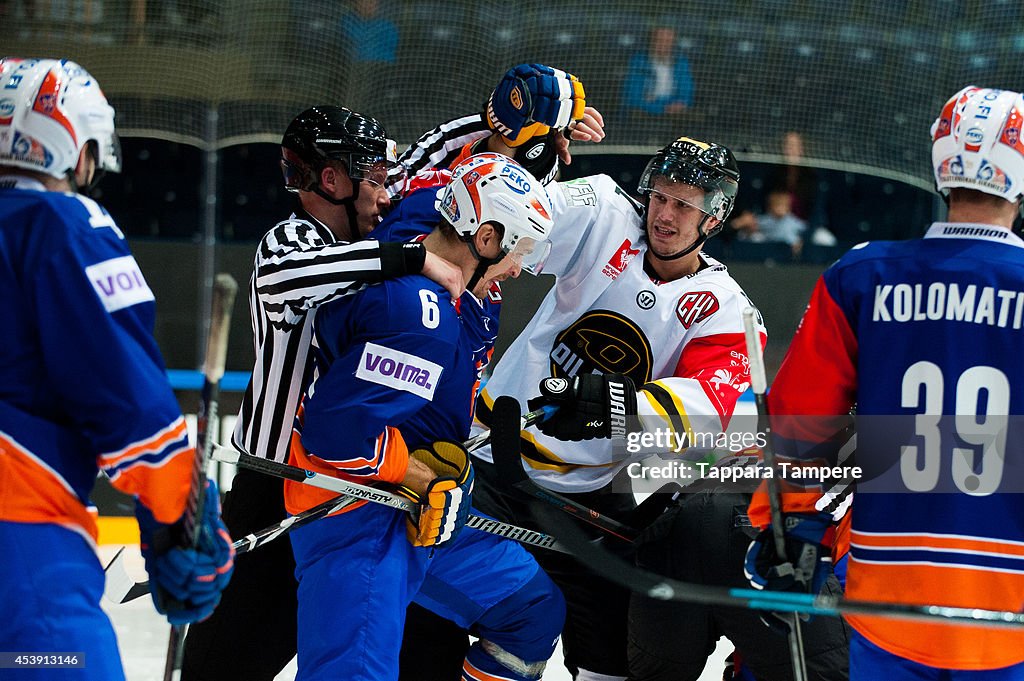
{"left": 181, "top": 470, "right": 298, "bottom": 681}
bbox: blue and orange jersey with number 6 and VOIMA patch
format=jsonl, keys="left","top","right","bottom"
{"left": 285, "top": 274, "right": 477, "bottom": 513}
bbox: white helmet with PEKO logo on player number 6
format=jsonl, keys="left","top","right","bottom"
{"left": 434, "top": 154, "right": 554, "bottom": 274}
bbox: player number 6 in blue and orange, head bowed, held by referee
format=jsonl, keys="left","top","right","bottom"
{"left": 285, "top": 155, "right": 564, "bottom": 681}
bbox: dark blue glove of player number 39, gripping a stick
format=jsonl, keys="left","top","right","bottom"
{"left": 743, "top": 513, "right": 836, "bottom": 594}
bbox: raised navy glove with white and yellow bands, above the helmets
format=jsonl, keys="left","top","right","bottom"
{"left": 484, "top": 63, "right": 587, "bottom": 146}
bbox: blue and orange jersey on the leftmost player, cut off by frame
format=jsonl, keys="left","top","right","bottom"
{"left": 0, "top": 177, "right": 195, "bottom": 541}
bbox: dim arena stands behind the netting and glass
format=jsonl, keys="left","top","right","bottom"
{"left": 8, "top": 0, "right": 1024, "bottom": 513}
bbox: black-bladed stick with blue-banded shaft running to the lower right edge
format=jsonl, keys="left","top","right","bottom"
{"left": 530, "top": 501, "right": 1024, "bottom": 628}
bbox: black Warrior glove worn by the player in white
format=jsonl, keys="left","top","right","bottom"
{"left": 528, "top": 374, "right": 637, "bottom": 440}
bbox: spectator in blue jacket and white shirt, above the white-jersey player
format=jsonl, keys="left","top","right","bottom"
{"left": 623, "top": 26, "right": 693, "bottom": 134}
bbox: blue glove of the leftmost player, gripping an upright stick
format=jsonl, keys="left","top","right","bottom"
{"left": 135, "top": 480, "right": 234, "bottom": 625}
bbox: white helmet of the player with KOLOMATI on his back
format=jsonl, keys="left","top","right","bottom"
{"left": 932, "top": 85, "right": 1024, "bottom": 203}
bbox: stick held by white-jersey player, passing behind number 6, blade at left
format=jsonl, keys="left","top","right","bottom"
{"left": 103, "top": 409, "right": 561, "bottom": 604}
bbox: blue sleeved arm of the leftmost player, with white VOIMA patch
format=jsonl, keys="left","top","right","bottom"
{"left": 31, "top": 209, "right": 195, "bottom": 522}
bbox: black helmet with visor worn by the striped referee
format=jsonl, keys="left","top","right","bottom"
{"left": 281, "top": 105, "right": 395, "bottom": 191}
